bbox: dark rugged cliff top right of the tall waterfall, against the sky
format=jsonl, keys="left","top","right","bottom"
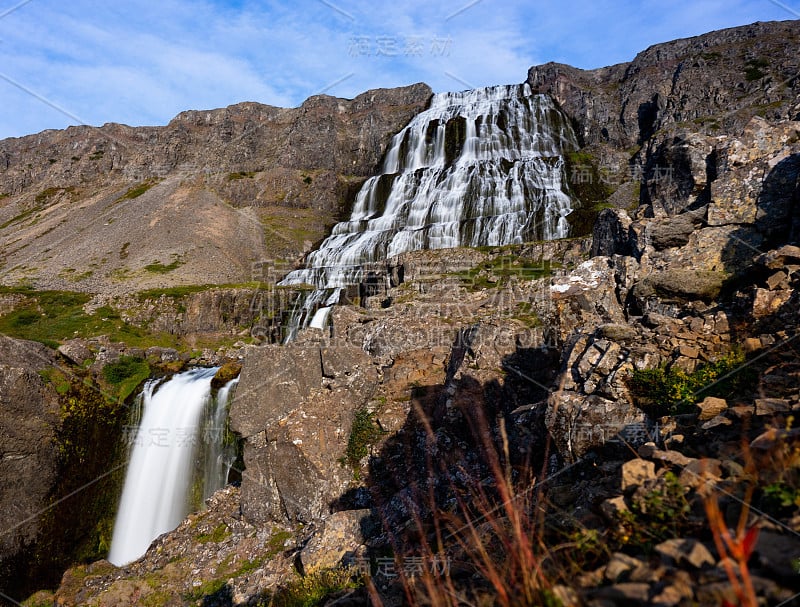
{"left": 528, "top": 21, "right": 800, "bottom": 149}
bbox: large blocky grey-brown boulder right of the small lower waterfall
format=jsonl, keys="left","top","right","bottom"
{"left": 230, "top": 343, "right": 377, "bottom": 523}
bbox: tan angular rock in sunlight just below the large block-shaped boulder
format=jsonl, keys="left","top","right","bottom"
{"left": 300, "top": 510, "right": 375, "bottom": 575}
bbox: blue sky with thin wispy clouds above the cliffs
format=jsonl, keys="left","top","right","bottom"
{"left": 0, "top": 0, "right": 800, "bottom": 138}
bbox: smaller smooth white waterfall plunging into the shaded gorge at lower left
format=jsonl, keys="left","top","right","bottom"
{"left": 108, "top": 368, "right": 238, "bottom": 565}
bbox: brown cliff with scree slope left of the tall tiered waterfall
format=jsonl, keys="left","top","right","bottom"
{"left": 0, "top": 84, "right": 431, "bottom": 292}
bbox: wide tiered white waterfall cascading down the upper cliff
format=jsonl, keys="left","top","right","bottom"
{"left": 280, "top": 84, "right": 579, "bottom": 340}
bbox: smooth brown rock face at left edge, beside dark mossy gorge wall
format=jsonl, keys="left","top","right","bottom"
{"left": 0, "top": 336, "right": 60, "bottom": 589}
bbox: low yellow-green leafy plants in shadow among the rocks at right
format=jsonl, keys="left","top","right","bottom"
{"left": 629, "top": 351, "right": 756, "bottom": 416}
